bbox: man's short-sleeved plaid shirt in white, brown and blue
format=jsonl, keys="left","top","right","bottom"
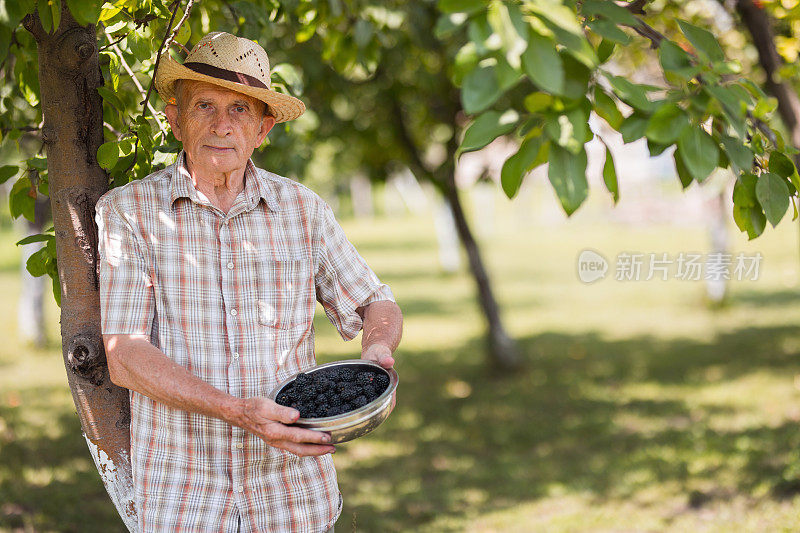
{"left": 97, "top": 154, "right": 393, "bottom": 532}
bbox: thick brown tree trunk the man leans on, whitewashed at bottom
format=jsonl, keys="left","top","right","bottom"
{"left": 23, "top": 2, "right": 136, "bottom": 530}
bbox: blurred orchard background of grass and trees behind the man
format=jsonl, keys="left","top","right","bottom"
{"left": 0, "top": 0, "right": 800, "bottom": 532}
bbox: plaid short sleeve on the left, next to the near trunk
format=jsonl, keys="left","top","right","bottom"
{"left": 96, "top": 200, "right": 155, "bottom": 335}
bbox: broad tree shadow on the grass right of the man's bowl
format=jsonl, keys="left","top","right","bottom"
{"left": 337, "top": 327, "right": 800, "bottom": 531}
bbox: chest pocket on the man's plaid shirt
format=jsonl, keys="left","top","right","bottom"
{"left": 256, "top": 256, "right": 314, "bottom": 329}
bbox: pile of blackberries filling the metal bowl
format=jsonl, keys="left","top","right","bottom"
{"left": 275, "top": 365, "right": 389, "bottom": 418}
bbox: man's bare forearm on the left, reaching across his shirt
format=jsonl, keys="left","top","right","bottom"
{"left": 103, "top": 335, "right": 242, "bottom": 425}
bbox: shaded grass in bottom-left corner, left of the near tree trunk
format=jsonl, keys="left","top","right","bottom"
{"left": 0, "top": 388, "right": 126, "bottom": 533}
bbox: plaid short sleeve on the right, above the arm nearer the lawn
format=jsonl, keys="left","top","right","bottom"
{"left": 314, "top": 202, "right": 394, "bottom": 340}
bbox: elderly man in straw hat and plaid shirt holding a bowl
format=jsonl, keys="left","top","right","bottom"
{"left": 97, "top": 33, "right": 402, "bottom": 532}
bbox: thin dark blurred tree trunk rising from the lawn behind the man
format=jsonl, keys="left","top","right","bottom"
{"left": 443, "top": 172, "right": 521, "bottom": 370}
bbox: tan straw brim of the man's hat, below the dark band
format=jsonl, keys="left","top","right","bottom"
{"left": 155, "top": 54, "right": 306, "bottom": 122}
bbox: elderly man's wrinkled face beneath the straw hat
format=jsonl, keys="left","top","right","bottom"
{"left": 164, "top": 80, "right": 275, "bottom": 180}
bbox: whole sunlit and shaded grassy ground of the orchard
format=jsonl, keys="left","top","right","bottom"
{"left": 0, "top": 189, "right": 800, "bottom": 532}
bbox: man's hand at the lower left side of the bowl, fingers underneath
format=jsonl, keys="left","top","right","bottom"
{"left": 238, "top": 397, "right": 336, "bottom": 457}
